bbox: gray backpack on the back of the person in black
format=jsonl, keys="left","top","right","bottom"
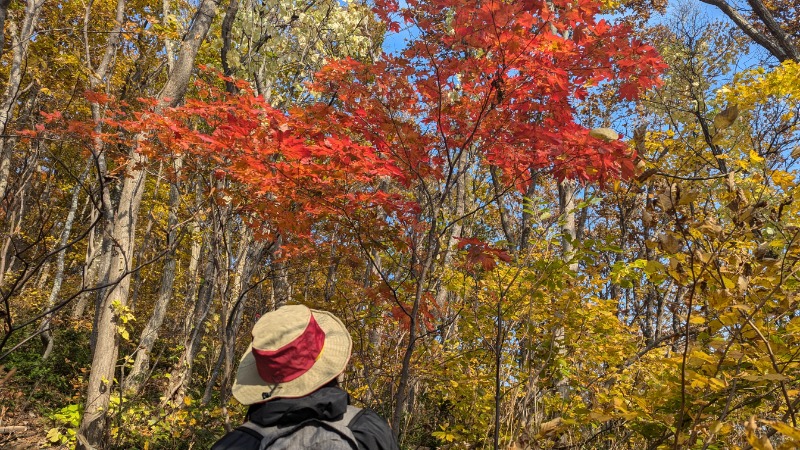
{"left": 242, "top": 405, "right": 361, "bottom": 450}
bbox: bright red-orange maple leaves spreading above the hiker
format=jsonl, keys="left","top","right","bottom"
{"left": 34, "top": 0, "right": 665, "bottom": 253}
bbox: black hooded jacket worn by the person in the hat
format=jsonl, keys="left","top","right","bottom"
{"left": 211, "top": 387, "right": 398, "bottom": 450}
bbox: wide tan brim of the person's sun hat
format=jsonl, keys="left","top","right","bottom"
{"left": 232, "top": 309, "right": 346, "bottom": 405}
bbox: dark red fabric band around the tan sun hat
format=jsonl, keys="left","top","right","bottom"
{"left": 253, "top": 314, "right": 325, "bottom": 383}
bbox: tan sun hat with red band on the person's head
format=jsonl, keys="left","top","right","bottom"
{"left": 233, "top": 305, "right": 352, "bottom": 405}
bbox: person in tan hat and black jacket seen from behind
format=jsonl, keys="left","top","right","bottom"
{"left": 212, "top": 305, "right": 398, "bottom": 450}
